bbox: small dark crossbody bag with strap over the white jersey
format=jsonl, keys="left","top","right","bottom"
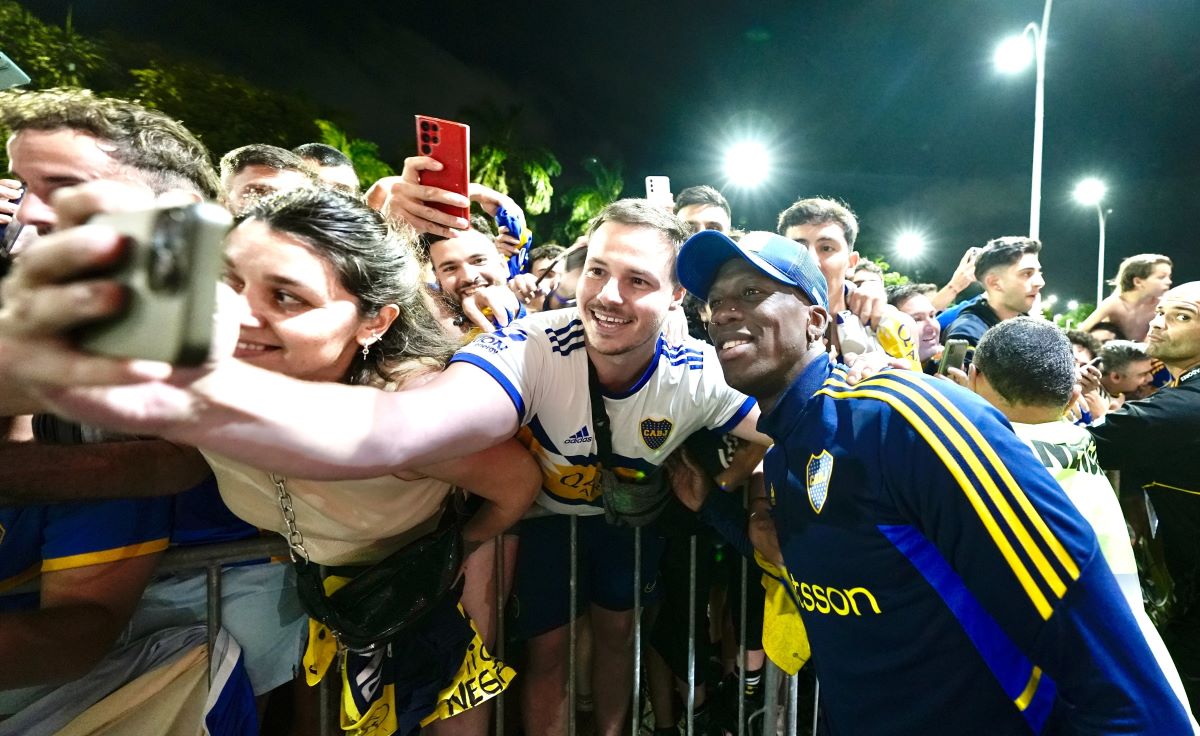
{"left": 588, "top": 360, "right": 671, "bottom": 527}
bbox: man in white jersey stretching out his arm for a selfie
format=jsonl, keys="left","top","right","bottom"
{"left": 0, "top": 193, "right": 767, "bottom": 735}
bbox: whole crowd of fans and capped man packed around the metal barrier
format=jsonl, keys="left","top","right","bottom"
{"left": 0, "top": 89, "right": 1200, "bottom": 736}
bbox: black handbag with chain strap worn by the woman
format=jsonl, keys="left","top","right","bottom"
{"left": 271, "top": 475, "right": 463, "bottom": 652}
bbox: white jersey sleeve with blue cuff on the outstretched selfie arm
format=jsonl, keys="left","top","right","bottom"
{"left": 450, "top": 322, "right": 549, "bottom": 425}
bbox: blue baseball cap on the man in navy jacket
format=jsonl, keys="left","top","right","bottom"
{"left": 676, "top": 231, "right": 829, "bottom": 307}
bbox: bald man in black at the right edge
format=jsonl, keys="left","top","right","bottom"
{"left": 1092, "top": 281, "right": 1200, "bottom": 712}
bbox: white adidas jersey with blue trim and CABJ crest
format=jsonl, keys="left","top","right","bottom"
{"left": 451, "top": 309, "right": 755, "bottom": 515}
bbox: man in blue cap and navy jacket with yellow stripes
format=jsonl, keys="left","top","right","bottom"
{"left": 678, "top": 231, "right": 1192, "bottom": 734}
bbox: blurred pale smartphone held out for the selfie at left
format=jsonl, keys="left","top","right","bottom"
{"left": 77, "top": 203, "right": 233, "bottom": 366}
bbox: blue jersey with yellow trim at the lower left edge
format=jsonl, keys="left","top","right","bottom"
{"left": 0, "top": 498, "right": 172, "bottom": 611}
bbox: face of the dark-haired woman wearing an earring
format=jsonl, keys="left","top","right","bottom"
{"left": 224, "top": 220, "right": 390, "bottom": 381}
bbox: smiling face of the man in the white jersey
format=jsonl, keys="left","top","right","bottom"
{"left": 575, "top": 221, "right": 683, "bottom": 369}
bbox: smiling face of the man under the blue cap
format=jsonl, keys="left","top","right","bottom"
{"left": 708, "top": 258, "right": 828, "bottom": 409}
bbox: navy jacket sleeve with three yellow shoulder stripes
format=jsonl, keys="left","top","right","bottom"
{"left": 862, "top": 375, "right": 1190, "bottom": 734}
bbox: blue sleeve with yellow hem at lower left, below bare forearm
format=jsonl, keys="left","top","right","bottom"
{"left": 42, "top": 497, "right": 172, "bottom": 573}
